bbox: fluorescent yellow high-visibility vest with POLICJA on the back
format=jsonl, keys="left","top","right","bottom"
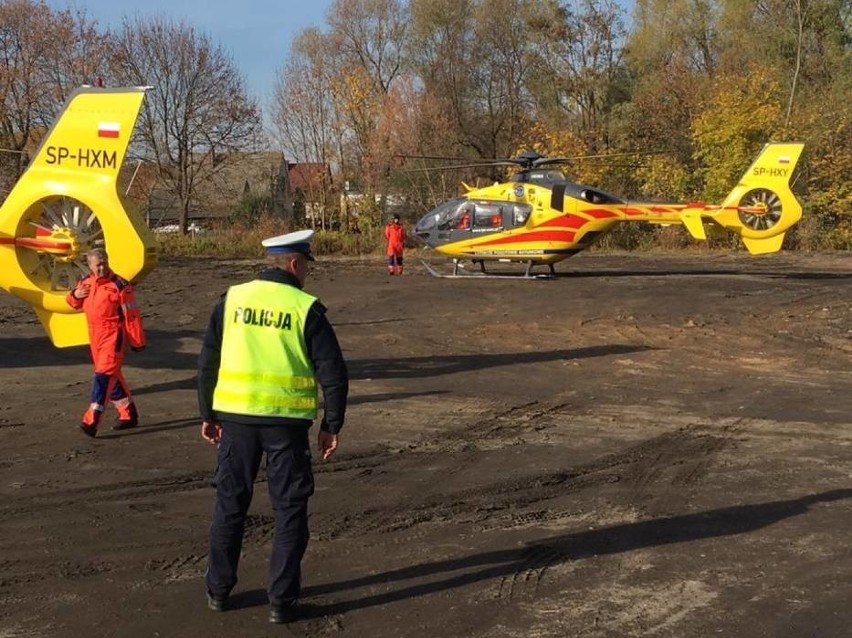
{"left": 213, "top": 280, "right": 317, "bottom": 420}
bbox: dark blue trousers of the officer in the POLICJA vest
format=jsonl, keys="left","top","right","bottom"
{"left": 206, "top": 421, "right": 314, "bottom": 605}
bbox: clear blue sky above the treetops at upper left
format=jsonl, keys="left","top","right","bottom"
{"left": 47, "top": 0, "right": 333, "bottom": 106}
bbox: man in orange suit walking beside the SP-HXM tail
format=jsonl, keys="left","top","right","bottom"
{"left": 66, "top": 248, "right": 145, "bottom": 437}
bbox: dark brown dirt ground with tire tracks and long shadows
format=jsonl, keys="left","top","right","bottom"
{"left": 0, "top": 252, "right": 852, "bottom": 638}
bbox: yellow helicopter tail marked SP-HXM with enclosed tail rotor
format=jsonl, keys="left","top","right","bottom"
{"left": 0, "top": 86, "right": 158, "bottom": 347}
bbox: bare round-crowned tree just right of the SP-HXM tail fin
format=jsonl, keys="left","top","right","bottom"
{"left": 112, "top": 17, "right": 261, "bottom": 233}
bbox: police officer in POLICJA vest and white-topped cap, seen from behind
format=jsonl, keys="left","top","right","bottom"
{"left": 198, "top": 230, "right": 349, "bottom": 623}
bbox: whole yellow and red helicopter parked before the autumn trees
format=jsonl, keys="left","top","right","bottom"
{"left": 414, "top": 143, "right": 804, "bottom": 277}
